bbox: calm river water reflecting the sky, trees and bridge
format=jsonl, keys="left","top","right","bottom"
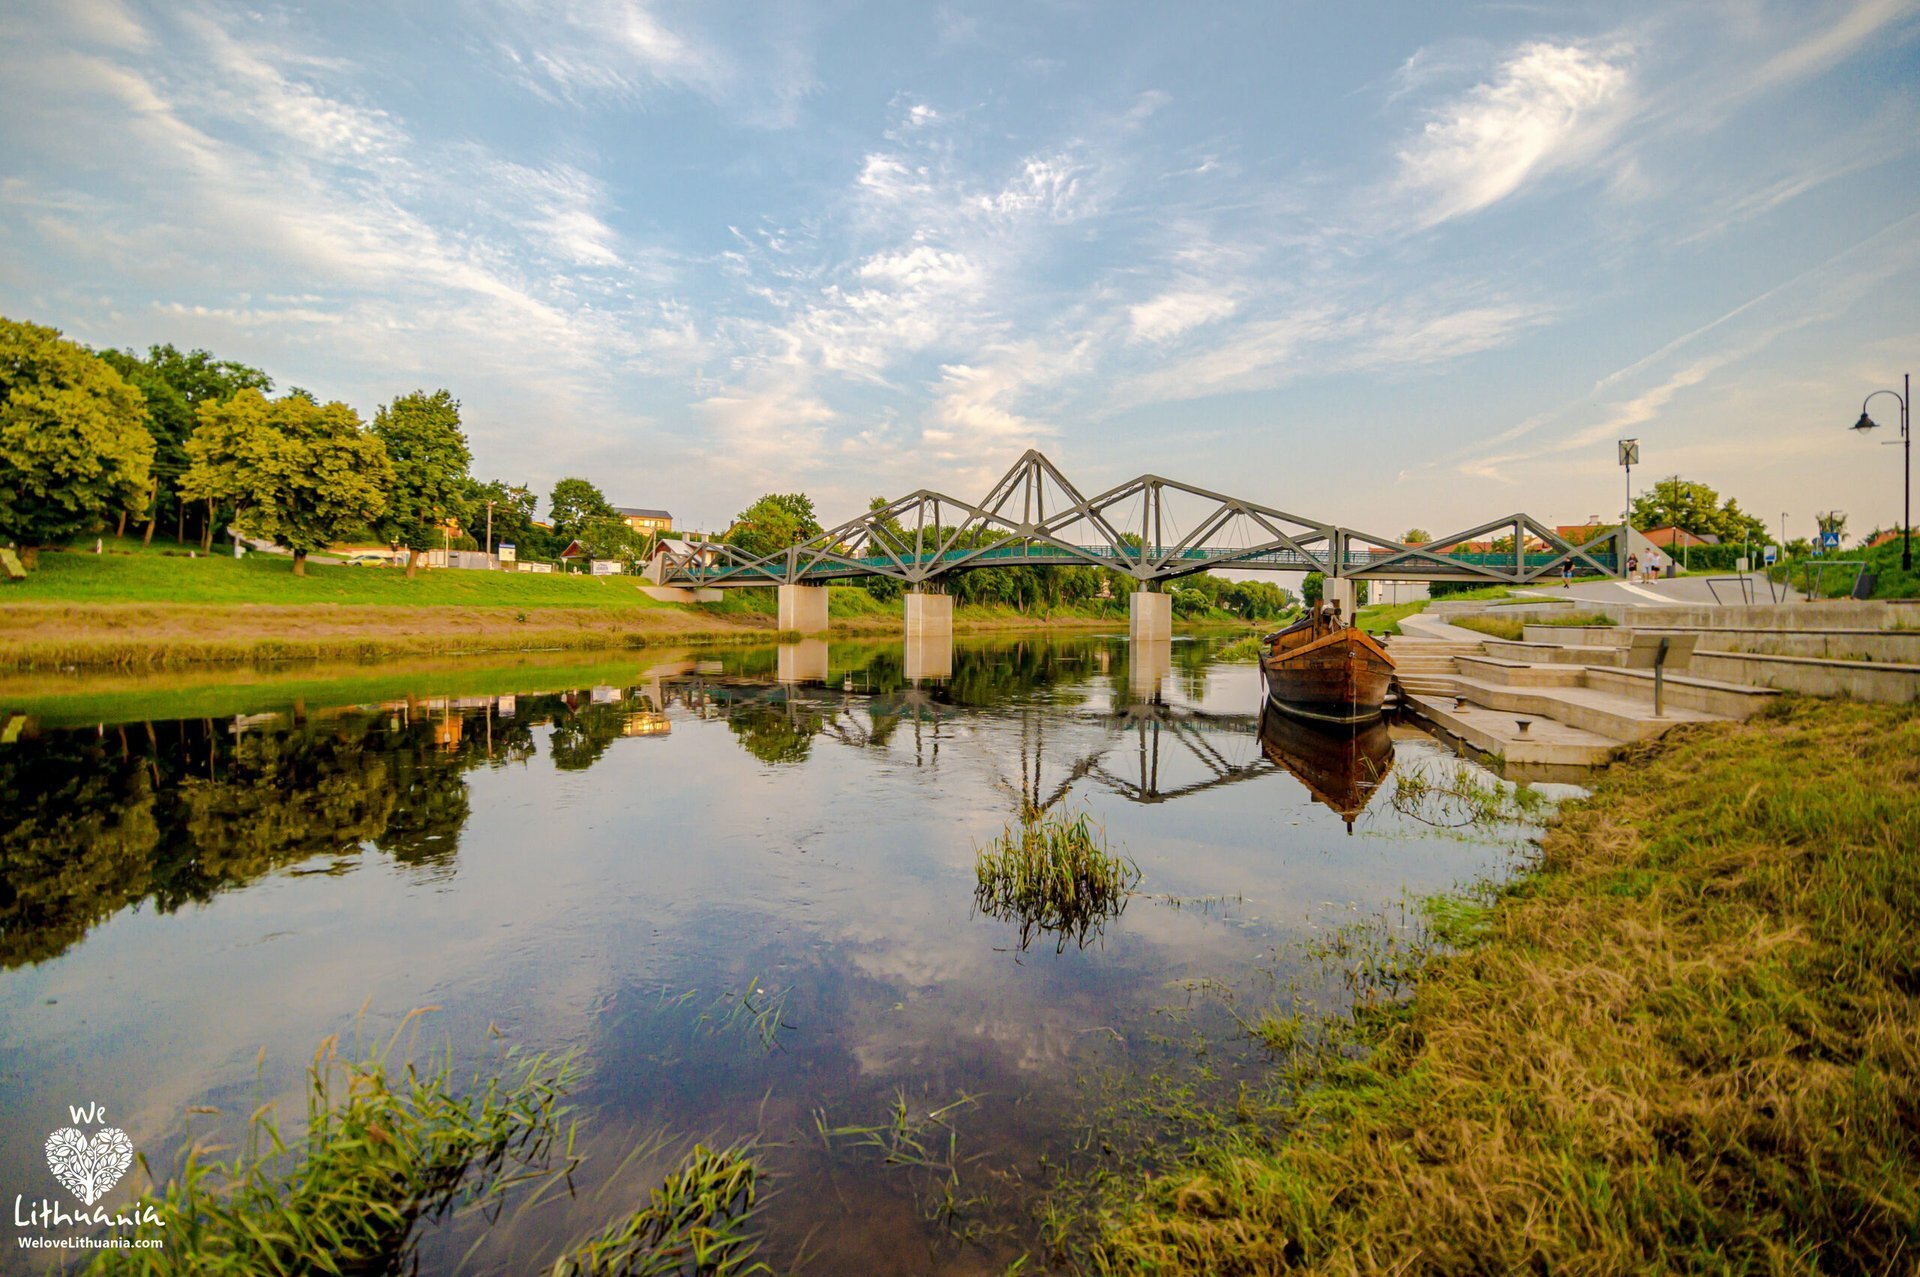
{"left": 0, "top": 638, "right": 1536, "bottom": 1273}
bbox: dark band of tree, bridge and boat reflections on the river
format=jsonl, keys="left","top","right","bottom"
{"left": 0, "top": 639, "right": 1392, "bottom": 966}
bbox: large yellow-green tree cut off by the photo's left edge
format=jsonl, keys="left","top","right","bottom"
{"left": 0, "top": 319, "right": 154, "bottom": 557}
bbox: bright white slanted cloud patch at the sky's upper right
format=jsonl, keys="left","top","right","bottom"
{"left": 1396, "top": 42, "right": 1630, "bottom": 227}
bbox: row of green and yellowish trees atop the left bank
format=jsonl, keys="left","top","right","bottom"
{"left": 0, "top": 317, "right": 647, "bottom": 576}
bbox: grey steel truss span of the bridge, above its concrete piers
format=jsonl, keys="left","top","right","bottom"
{"left": 657, "top": 449, "right": 1626, "bottom": 590}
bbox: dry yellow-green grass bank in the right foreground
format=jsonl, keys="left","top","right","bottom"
{"left": 1094, "top": 701, "right": 1920, "bottom": 1273}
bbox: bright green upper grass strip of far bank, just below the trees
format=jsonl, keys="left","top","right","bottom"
{"left": 0, "top": 542, "right": 668, "bottom": 609}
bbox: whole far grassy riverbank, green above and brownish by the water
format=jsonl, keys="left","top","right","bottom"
{"left": 0, "top": 543, "right": 1244, "bottom": 670}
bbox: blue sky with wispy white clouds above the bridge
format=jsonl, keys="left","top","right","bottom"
{"left": 0, "top": 0, "right": 1920, "bottom": 536}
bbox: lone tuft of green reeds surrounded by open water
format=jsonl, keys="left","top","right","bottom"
{"left": 973, "top": 807, "right": 1140, "bottom": 952}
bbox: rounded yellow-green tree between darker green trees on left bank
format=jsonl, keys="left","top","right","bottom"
{"left": 180, "top": 390, "right": 394, "bottom": 576}
